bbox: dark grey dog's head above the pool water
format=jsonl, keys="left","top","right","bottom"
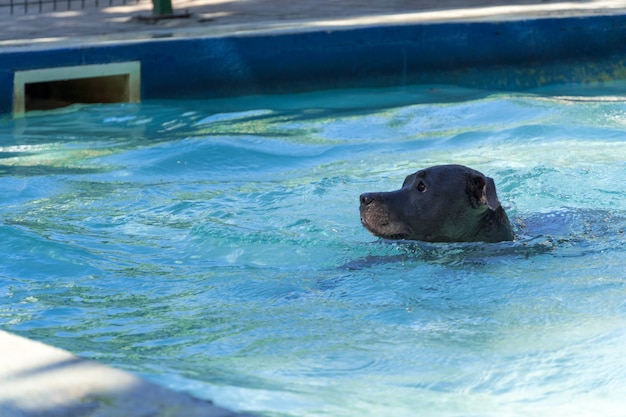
{"left": 360, "top": 165, "right": 513, "bottom": 242}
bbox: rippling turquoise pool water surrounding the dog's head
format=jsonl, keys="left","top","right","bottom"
{"left": 0, "top": 84, "right": 626, "bottom": 417}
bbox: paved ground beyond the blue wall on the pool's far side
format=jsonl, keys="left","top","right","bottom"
{"left": 0, "top": 0, "right": 626, "bottom": 46}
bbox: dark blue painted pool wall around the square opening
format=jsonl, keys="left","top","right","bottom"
{"left": 0, "top": 15, "right": 626, "bottom": 113}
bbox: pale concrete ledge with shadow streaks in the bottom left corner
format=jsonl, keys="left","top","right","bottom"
{"left": 0, "top": 331, "right": 250, "bottom": 417}
